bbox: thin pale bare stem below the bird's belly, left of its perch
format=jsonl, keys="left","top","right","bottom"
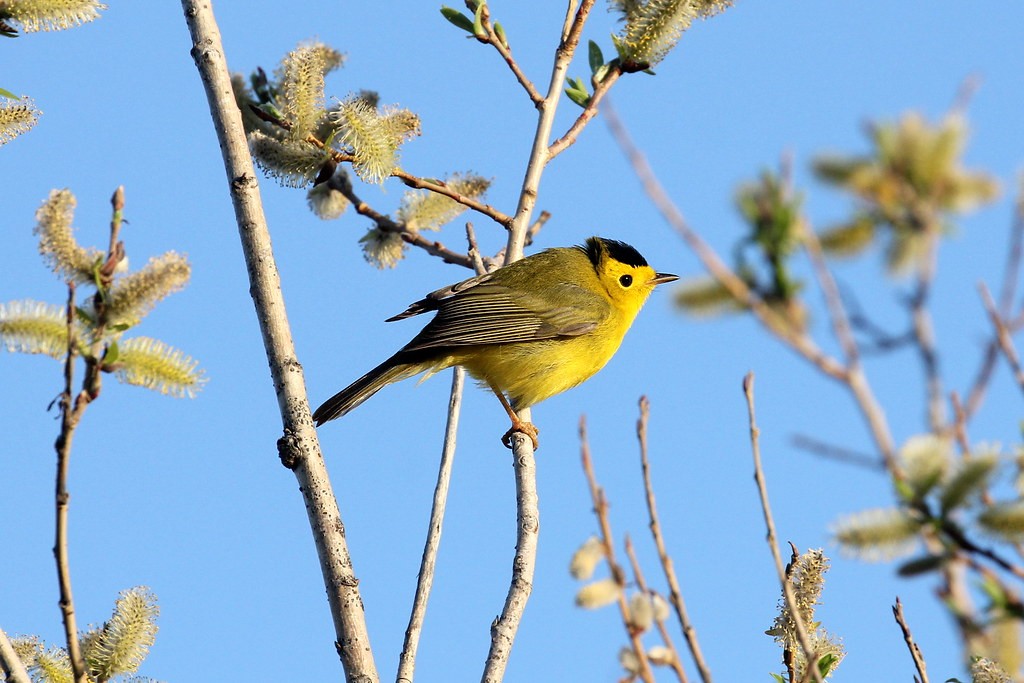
{"left": 396, "top": 367, "right": 466, "bottom": 683}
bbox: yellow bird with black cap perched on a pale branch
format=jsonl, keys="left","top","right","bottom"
{"left": 312, "top": 237, "right": 678, "bottom": 450}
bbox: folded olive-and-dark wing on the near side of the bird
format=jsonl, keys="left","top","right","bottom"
{"left": 402, "top": 281, "right": 610, "bottom": 351}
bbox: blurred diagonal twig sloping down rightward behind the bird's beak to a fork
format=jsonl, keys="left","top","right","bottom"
{"left": 602, "top": 102, "right": 848, "bottom": 381}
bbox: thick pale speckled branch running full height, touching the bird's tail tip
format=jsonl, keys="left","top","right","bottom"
{"left": 181, "top": 0, "right": 379, "bottom": 683}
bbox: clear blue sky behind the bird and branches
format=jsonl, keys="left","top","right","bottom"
{"left": 0, "top": 0, "right": 1024, "bottom": 681}
